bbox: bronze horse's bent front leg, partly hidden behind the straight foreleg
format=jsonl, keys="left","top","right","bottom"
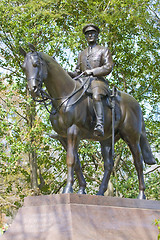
{"left": 58, "top": 136, "right": 86, "bottom": 194}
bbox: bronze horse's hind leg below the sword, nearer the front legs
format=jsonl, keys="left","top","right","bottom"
{"left": 97, "top": 139, "right": 114, "bottom": 196}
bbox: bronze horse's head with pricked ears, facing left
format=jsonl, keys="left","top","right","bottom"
{"left": 20, "top": 44, "right": 47, "bottom": 98}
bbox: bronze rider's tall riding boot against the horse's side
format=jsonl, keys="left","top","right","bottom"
{"left": 93, "top": 100, "right": 104, "bottom": 136}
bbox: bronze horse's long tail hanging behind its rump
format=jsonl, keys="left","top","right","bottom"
{"left": 140, "top": 117, "right": 156, "bottom": 165}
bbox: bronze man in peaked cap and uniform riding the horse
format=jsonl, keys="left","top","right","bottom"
{"left": 69, "top": 24, "right": 113, "bottom": 136}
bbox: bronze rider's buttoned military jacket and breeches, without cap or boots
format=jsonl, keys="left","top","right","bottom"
{"left": 74, "top": 45, "right": 113, "bottom": 99}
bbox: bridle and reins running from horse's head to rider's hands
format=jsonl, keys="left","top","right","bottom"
{"left": 28, "top": 52, "right": 90, "bottom": 115}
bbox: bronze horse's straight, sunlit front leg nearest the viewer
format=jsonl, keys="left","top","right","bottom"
{"left": 63, "top": 125, "right": 79, "bottom": 193}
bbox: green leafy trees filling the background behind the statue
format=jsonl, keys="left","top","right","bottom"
{"left": 0, "top": 0, "right": 160, "bottom": 219}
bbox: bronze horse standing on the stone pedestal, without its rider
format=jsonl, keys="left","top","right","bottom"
{"left": 20, "top": 45, "right": 155, "bottom": 199}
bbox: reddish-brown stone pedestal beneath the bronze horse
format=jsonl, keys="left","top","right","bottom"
{"left": 0, "top": 194, "right": 160, "bottom": 240}
